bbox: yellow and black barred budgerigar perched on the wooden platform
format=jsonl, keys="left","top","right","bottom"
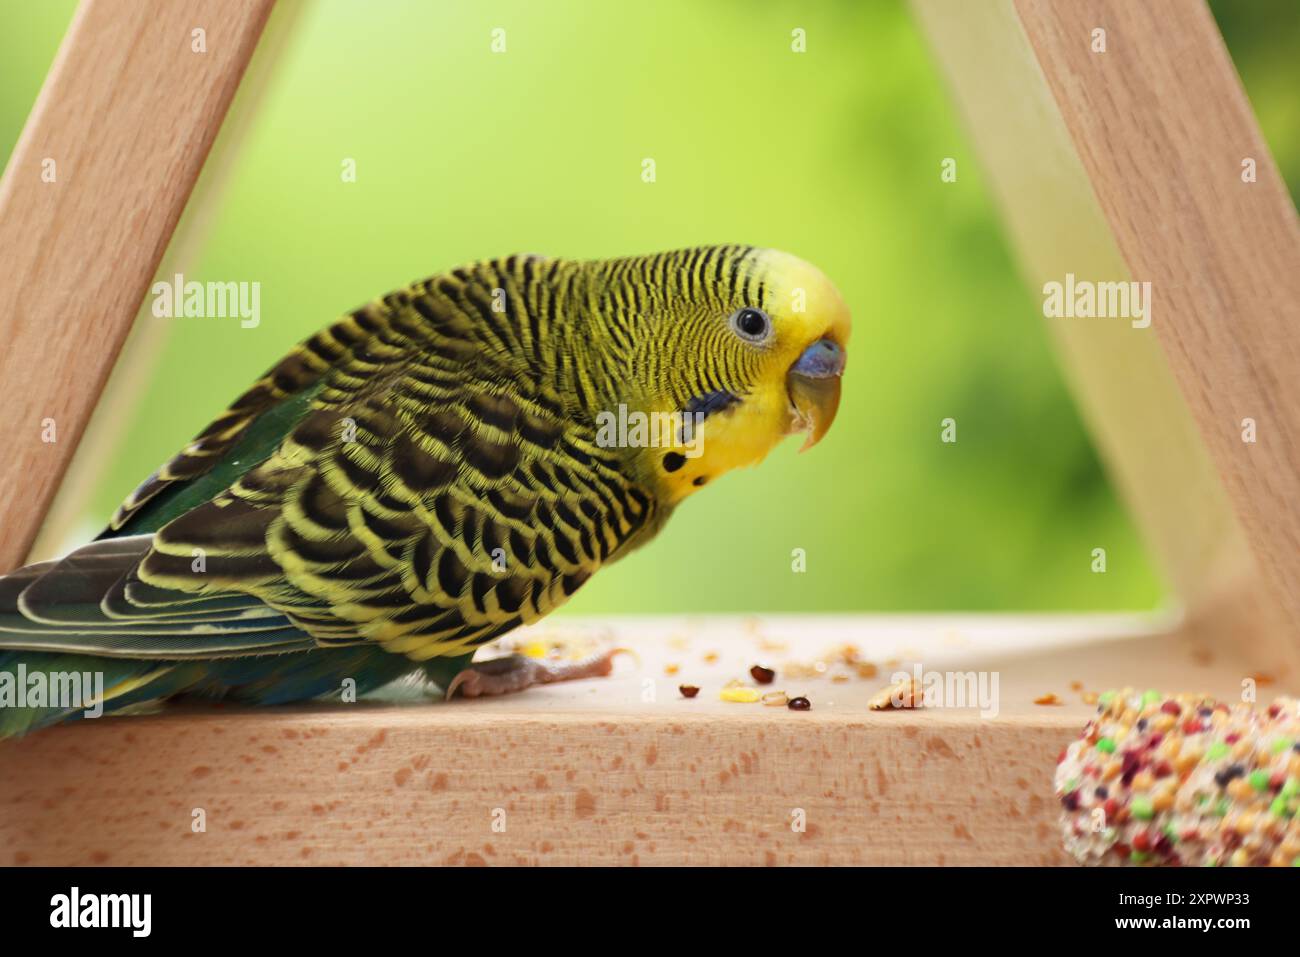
{"left": 0, "top": 246, "right": 849, "bottom": 737}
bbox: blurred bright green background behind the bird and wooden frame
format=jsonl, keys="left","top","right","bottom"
{"left": 0, "top": 0, "right": 1300, "bottom": 614}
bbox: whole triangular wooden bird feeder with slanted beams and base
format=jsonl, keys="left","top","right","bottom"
{"left": 0, "top": 0, "right": 1300, "bottom": 865}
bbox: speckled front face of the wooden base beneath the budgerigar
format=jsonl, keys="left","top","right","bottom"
{"left": 0, "top": 706, "right": 1070, "bottom": 866}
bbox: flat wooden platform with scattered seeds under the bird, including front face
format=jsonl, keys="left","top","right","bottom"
{"left": 0, "top": 616, "right": 1277, "bottom": 865}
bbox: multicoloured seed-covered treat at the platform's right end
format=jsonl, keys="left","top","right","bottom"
{"left": 1056, "top": 689, "right": 1300, "bottom": 866}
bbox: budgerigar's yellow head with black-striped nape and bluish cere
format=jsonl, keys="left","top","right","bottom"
{"left": 582, "top": 246, "right": 850, "bottom": 503}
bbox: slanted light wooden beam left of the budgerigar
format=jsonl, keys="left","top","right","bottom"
{"left": 0, "top": 0, "right": 274, "bottom": 571}
